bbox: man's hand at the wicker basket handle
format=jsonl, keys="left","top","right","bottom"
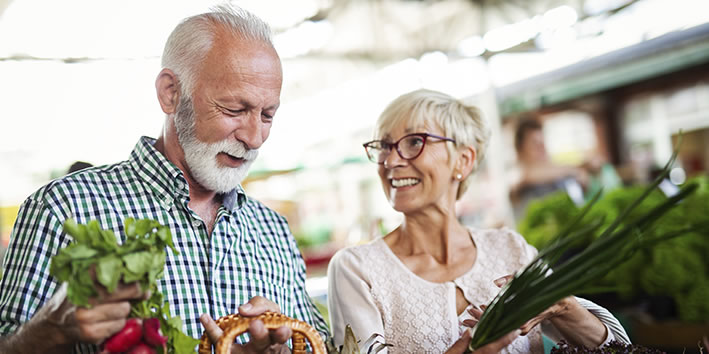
{"left": 199, "top": 296, "right": 293, "bottom": 354}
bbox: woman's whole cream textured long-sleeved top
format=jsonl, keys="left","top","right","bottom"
{"left": 328, "top": 228, "right": 624, "bottom": 353}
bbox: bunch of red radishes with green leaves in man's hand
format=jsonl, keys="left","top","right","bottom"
{"left": 50, "top": 218, "right": 199, "bottom": 354}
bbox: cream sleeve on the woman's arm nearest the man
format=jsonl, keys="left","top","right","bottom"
{"left": 327, "top": 249, "right": 386, "bottom": 346}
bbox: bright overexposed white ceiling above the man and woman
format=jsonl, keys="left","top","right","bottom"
{"left": 0, "top": 0, "right": 709, "bottom": 205}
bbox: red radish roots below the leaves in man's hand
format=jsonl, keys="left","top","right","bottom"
{"left": 103, "top": 318, "right": 167, "bottom": 354}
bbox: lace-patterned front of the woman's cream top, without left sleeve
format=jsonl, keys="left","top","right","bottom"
{"left": 352, "top": 229, "right": 543, "bottom": 353}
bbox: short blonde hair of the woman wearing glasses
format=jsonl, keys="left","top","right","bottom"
{"left": 374, "top": 89, "right": 490, "bottom": 199}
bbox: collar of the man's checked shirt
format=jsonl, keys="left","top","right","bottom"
{"left": 130, "top": 136, "right": 248, "bottom": 212}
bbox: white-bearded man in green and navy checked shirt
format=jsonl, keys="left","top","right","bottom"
{"left": 0, "top": 7, "right": 328, "bottom": 353}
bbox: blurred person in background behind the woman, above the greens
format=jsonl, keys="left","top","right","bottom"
{"left": 510, "top": 118, "right": 621, "bottom": 220}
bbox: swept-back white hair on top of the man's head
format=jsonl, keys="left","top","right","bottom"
{"left": 162, "top": 5, "right": 273, "bottom": 97}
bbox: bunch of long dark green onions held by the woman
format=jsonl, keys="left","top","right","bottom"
{"left": 470, "top": 152, "right": 709, "bottom": 350}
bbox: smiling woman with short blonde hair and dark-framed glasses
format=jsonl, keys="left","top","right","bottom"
{"left": 328, "top": 90, "right": 628, "bottom": 353}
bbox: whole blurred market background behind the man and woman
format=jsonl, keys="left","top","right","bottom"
{"left": 0, "top": 0, "right": 709, "bottom": 352}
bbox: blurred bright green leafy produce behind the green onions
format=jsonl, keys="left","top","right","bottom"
{"left": 519, "top": 176, "right": 709, "bottom": 322}
